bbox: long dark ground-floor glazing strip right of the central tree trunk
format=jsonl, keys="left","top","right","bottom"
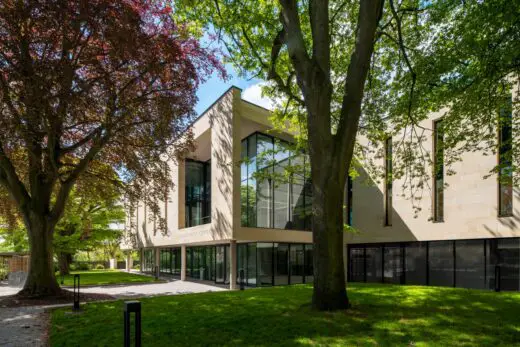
{"left": 348, "top": 238, "right": 520, "bottom": 291}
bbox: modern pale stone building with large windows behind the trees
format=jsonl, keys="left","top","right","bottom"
{"left": 123, "top": 88, "right": 520, "bottom": 290}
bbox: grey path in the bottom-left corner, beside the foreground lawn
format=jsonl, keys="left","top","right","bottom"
{"left": 0, "top": 307, "right": 48, "bottom": 347}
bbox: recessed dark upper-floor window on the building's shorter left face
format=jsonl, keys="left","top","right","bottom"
{"left": 185, "top": 160, "right": 211, "bottom": 227}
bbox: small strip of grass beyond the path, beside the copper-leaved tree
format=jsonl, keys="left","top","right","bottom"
{"left": 58, "top": 270, "right": 155, "bottom": 286}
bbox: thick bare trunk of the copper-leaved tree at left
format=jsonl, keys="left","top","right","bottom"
{"left": 18, "top": 213, "right": 61, "bottom": 297}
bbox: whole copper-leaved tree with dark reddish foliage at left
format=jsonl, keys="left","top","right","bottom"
{"left": 0, "top": 0, "right": 224, "bottom": 296}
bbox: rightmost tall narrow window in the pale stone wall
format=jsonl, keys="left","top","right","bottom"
{"left": 498, "top": 99, "right": 513, "bottom": 217}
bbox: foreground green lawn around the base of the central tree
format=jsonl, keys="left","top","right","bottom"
{"left": 50, "top": 284, "right": 520, "bottom": 346}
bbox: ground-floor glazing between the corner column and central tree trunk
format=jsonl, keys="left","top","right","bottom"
{"left": 237, "top": 242, "right": 314, "bottom": 287}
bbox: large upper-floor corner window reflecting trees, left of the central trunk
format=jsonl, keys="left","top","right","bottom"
{"left": 240, "top": 133, "right": 312, "bottom": 230}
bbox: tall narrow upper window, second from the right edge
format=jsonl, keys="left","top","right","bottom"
{"left": 433, "top": 120, "right": 444, "bottom": 222}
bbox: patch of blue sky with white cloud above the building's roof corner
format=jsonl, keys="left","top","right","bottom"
{"left": 195, "top": 64, "right": 269, "bottom": 115}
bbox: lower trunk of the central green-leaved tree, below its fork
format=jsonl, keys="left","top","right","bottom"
{"left": 312, "top": 156, "right": 349, "bottom": 311}
